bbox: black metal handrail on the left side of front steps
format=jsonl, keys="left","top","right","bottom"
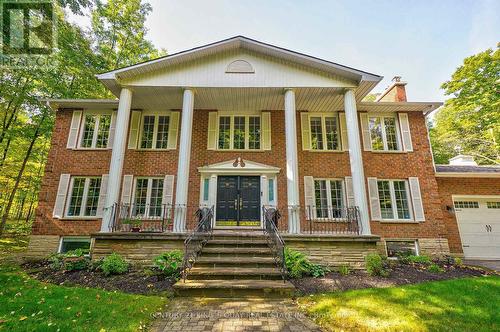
{"left": 182, "top": 206, "right": 214, "bottom": 282}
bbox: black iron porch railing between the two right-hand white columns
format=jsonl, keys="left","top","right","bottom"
{"left": 304, "top": 205, "right": 361, "bottom": 235}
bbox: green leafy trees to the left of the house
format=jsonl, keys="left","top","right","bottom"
{"left": 0, "top": 0, "right": 161, "bottom": 234}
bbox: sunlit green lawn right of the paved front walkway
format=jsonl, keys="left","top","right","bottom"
{"left": 299, "top": 276, "right": 500, "bottom": 332}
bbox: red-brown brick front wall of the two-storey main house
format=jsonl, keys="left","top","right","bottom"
{"left": 33, "top": 110, "right": 454, "bottom": 253}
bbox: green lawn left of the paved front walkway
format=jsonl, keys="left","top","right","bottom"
{"left": 0, "top": 266, "right": 166, "bottom": 332}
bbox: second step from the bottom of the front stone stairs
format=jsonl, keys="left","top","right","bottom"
{"left": 188, "top": 266, "right": 282, "bottom": 280}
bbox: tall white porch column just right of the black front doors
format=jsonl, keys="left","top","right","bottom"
{"left": 285, "top": 89, "right": 300, "bottom": 234}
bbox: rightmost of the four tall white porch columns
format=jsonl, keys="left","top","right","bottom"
{"left": 344, "top": 89, "right": 371, "bottom": 235}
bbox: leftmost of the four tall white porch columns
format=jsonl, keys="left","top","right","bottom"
{"left": 101, "top": 88, "right": 132, "bottom": 233}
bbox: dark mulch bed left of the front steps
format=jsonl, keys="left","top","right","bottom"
{"left": 22, "top": 261, "right": 175, "bottom": 295}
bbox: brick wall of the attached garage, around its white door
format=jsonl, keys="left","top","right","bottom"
{"left": 437, "top": 178, "right": 500, "bottom": 254}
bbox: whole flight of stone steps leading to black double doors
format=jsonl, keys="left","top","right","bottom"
{"left": 174, "top": 229, "right": 295, "bottom": 297}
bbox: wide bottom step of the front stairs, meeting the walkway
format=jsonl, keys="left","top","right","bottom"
{"left": 173, "top": 279, "right": 295, "bottom": 297}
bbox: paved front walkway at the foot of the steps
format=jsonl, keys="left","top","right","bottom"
{"left": 152, "top": 298, "right": 321, "bottom": 332}
